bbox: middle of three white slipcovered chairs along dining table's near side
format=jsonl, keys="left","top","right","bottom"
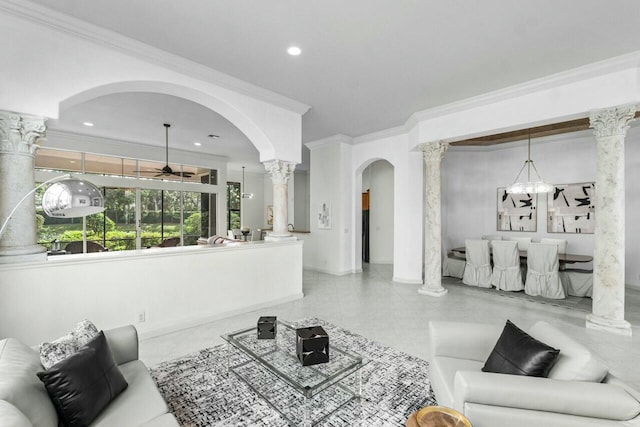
{"left": 491, "top": 240, "right": 524, "bottom": 291}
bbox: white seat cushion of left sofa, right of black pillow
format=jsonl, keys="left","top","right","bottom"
{"left": 91, "top": 360, "right": 168, "bottom": 427}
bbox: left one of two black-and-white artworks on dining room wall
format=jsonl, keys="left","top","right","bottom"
{"left": 498, "top": 187, "right": 538, "bottom": 231}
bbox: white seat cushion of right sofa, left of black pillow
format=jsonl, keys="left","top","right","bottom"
{"left": 429, "top": 356, "right": 483, "bottom": 408}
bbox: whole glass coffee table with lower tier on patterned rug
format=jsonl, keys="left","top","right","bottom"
{"left": 222, "top": 320, "right": 365, "bottom": 427}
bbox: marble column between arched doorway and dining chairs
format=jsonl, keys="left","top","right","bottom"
{"left": 418, "top": 141, "right": 449, "bottom": 297}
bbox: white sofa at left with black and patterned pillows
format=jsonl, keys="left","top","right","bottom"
{"left": 0, "top": 326, "right": 178, "bottom": 427}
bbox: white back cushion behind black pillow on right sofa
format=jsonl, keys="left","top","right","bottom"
{"left": 529, "top": 321, "right": 609, "bottom": 383}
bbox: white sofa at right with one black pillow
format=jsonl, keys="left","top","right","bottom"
{"left": 429, "top": 321, "right": 640, "bottom": 427}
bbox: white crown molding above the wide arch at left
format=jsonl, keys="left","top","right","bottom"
{"left": 0, "top": 0, "right": 311, "bottom": 115}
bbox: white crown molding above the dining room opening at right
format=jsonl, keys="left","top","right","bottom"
{"left": 405, "top": 50, "right": 640, "bottom": 123}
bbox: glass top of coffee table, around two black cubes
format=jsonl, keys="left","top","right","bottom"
{"left": 222, "top": 320, "right": 363, "bottom": 398}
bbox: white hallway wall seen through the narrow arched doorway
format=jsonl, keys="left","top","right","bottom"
{"left": 362, "top": 160, "right": 394, "bottom": 264}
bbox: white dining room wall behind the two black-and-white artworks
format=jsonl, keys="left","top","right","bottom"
{"left": 442, "top": 127, "right": 640, "bottom": 287}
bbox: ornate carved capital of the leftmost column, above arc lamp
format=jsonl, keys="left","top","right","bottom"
{"left": 0, "top": 111, "right": 47, "bottom": 156}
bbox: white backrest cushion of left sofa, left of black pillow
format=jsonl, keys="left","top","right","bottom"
{"left": 0, "top": 338, "right": 58, "bottom": 427}
